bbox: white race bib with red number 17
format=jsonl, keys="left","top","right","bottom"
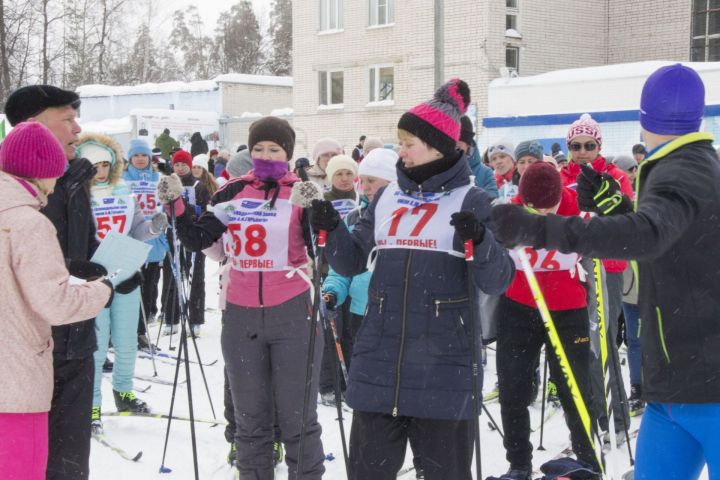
{"left": 375, "top": 182, "right": 471, "bottom": 256}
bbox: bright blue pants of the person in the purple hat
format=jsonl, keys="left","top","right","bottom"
{"left": 635, "top": 403, "right": 720, "bottom": 480}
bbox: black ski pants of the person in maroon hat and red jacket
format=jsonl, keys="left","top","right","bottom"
{"left": 496, "top": 295, "right": 599, "bottom": 471}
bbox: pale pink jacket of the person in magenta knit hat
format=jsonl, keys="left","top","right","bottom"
{"left": 0, "top": 173, "right": 110, "bottom": 413}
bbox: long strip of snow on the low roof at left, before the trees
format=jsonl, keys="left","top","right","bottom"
{"left": 75, "top": 73, "right": 293, "bottom": 98}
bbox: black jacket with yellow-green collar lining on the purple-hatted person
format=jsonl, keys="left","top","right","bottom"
{"left": 545, "top": 133, "right": 720, "bottom": 403}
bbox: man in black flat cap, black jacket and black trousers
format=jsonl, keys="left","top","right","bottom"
{"left": 5, "top": 85, "right": 103, "bottom": 480}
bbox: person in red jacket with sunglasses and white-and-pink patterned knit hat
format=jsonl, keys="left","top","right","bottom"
{"left": 560, "top": 113, "right": 635, "bottom": 443}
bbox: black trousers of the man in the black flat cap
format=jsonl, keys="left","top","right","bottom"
{"left": 47, "top": 355, "right": 95, "bottom": 480}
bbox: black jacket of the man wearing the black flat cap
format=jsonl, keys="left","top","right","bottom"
{"left": 42, "top": 158, "right": 98, "bottom": 360}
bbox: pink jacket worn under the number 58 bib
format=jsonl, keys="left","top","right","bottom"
{"left": 227, "top": 171, "right": 310, "bottom": 307}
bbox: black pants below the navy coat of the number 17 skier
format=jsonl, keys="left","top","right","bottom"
{"left": 350, "top": 410, "right": 474, "bottom": 480}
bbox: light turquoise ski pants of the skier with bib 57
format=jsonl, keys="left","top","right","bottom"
{"left": 93, "top": 288, "right": 140, "bottom": 406}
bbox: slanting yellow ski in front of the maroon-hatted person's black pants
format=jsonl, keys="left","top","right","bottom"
{"left": 515, "top": 247, "right": 605, "bottom": 476}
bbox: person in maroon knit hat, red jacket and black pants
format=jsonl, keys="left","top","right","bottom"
{"left": 496, "top": 162, "right": 599, "bottom": 480}
